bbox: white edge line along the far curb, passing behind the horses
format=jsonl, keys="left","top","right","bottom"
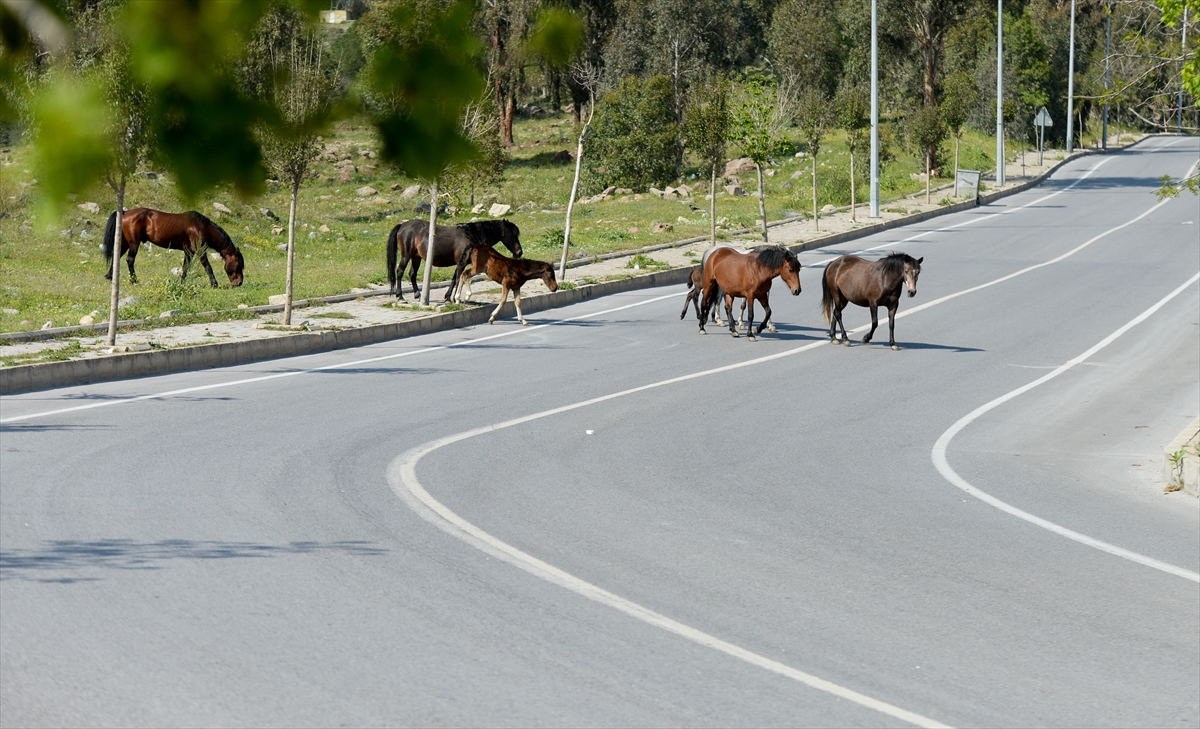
{"left": 0, "top": 151, "right": 1111, "bottom": 424}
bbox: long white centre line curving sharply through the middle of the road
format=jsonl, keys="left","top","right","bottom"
{"left": 386, "top": 153, "right": 1200, "bottom": 727}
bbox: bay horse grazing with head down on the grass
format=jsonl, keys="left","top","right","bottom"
{"left": 103, "top": 207, "right": 246, "bottom": 289}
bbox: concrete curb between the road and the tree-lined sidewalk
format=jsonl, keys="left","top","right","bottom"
{"left": 0, "top": 145, "right": 1104, "bottom": 396}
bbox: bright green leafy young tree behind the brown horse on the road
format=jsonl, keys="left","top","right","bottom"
{"left": 729, "top": 77, "right": 794, "bottom": 242}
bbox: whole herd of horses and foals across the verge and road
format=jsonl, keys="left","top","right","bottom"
{"left": 103, "top": 207, "right": 924, "bottom": 349}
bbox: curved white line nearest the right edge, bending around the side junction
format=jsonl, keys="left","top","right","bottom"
{"left": 932, "top": 273, "right": 1200, "bottom": 583}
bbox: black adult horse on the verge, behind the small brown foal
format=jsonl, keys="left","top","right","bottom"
{"left": 388, "top": 218, "right": 522, "bottom": 301}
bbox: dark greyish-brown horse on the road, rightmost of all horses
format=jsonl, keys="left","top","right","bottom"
{"left": 821, "top": 253, "right": 925, "bottom": 349}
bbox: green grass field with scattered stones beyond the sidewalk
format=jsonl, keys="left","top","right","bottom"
{"left": 0, "top": 114, "right": 991, "bottom": 332}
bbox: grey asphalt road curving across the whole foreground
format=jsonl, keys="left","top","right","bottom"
{"left": 7, "top": 138, "right": 1200, "bottom": 727}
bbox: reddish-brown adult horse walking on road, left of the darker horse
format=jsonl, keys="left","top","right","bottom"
{"left": 700, "top": 246, "right": 800, "bottom": 342}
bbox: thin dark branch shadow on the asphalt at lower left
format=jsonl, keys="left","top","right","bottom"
{"left": 0, "top": 540, "right": 386, "bottom": 584}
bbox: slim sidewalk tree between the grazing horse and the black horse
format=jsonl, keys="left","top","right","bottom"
{"left": 242, "top": 5, "right": 336, "bottom": 325}
